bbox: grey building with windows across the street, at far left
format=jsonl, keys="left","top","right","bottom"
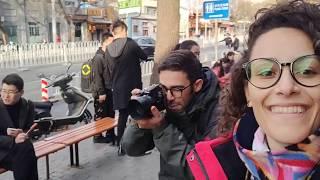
{"left": 0, "top": 0, "right": 68, "bottom": 43}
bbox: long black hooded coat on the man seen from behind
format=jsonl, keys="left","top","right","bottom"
{"left": 106, "top": 38, "right": 147, "bottom": 110}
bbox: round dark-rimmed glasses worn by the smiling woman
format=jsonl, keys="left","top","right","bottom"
{"left": 242, "top": 55, "right": 320, "bottom": 89}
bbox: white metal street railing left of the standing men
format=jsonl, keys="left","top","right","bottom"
{"left": 0, "top": 41, "right": 99, "bottom": 69}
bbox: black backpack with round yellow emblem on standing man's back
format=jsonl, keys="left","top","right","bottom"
{"left": 81, "top": 58, "right": 94, "bottom": 93}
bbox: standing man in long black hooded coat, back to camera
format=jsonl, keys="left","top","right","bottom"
{"left": 107, "top": 20, "right": 147, "bottom": 155}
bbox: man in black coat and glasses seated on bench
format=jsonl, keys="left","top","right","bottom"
{"left": 0, "top": 74, "right": 38, "bottom": 180}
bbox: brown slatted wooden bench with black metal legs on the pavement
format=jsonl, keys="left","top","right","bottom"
{"left": 0, "top": 117, "right": 117, "bottom": 179}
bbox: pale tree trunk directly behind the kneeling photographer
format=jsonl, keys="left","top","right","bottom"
{"left": 150, "top": 0, "right": 180, "bottom": 84}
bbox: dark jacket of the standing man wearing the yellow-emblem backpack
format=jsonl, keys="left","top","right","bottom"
{"left": 92, "top": 47, "right": 113, "bottom": 97}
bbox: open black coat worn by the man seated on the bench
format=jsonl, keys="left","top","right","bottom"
{"left": 0, "top": 98, "right": 34, "bottom": 161}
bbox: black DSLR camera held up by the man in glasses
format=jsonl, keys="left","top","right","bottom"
{"left": 128, "top": 84, "right": 165, "bottom": 120}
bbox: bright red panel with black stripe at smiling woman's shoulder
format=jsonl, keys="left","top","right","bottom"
{"left": 187, "top": 134, "right": 232, "bottom": 180}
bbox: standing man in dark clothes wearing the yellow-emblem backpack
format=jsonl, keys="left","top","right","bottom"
{"left": 92, "top": 33, "right": 114, "bottom": 143}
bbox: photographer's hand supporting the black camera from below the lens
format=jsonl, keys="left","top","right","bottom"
{"left": 136, "top": 106, "right": 165, "bottom": 129}
